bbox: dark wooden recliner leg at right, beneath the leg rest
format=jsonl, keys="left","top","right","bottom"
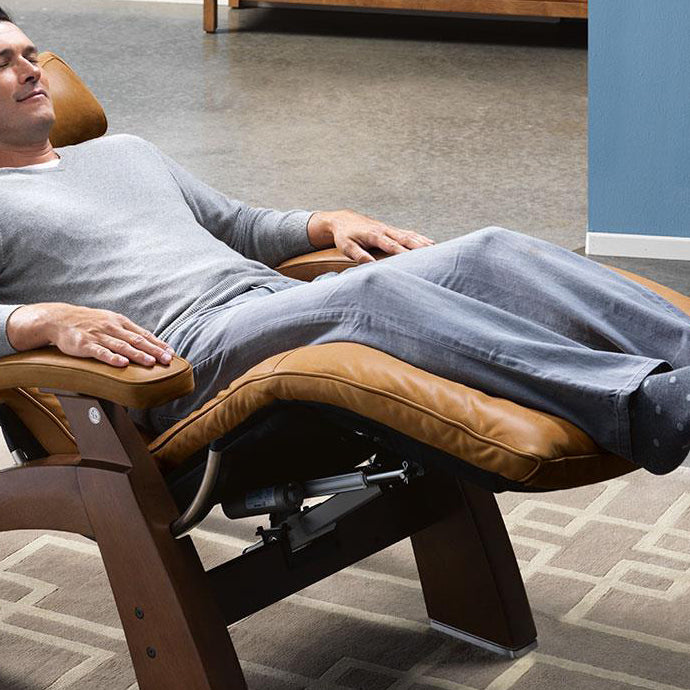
{"left": 411, "top": 472, "right": 537, "bottom": 658}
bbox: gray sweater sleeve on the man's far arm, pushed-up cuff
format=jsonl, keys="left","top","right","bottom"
{"left": 142, "top": 139, "right": 316, "bottom": 268}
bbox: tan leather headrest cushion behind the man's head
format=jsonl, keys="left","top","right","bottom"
{"left": 38, "top": 52, "right": 108, "bottom": 148}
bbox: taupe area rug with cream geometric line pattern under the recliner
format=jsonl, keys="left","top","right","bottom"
{"left": 0, "top": 467, "right": 690, "bottom": 690}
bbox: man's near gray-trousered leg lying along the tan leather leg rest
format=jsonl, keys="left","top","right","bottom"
{"left": 151, "top": 260, "right": 668, "bottom": 468}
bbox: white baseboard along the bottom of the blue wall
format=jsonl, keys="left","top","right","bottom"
{"left": 585, "top": 232, "right": 690, "bottom": 261}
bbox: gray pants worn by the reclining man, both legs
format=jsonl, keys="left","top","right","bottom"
{"left": 141, "top": 227, "right": 690, "bottom": 458}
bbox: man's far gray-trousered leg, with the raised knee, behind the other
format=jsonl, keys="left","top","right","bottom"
{"left": 362, "top": 227, "right": 690, "bottom": 368}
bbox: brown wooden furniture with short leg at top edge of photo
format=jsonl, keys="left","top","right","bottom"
{"left": 204, "top": 0, "right": 587, "bottom": 33}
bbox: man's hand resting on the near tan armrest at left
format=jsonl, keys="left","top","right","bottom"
{"left": 7, "top": 302, "right": 175, "bottom": 367}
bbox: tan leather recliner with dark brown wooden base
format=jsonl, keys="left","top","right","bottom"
{"left": 0, "top": 53, "right": 690, "bottom": 690}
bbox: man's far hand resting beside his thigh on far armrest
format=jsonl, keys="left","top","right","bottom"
{"left": 307, "top": 209, "right": 434, "bottom": 264}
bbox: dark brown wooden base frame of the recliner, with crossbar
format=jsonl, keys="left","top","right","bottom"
{"left": 0, "top": 390, "right": 536, "bottom": 690}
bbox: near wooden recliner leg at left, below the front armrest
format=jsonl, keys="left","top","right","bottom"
{"left": 59, "top": 395, "right": 246, "bottom": 690}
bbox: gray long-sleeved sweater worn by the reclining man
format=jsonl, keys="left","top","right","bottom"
{"left": 0, "top": 134, "right": 315, "bottom": 356}
